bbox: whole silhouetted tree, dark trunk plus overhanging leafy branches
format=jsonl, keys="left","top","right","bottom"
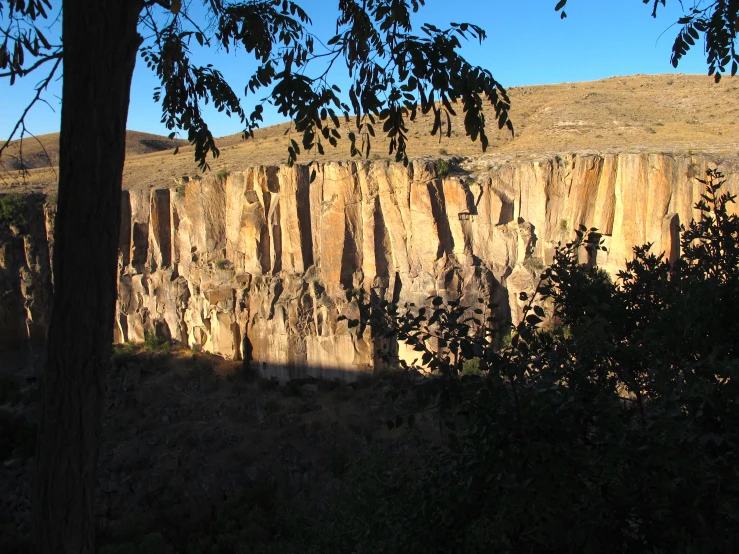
{"left": 0, "top": 0, "right": 739, "bottom": 554}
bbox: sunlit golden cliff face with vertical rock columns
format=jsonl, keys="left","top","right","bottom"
{"left": 0, "top": 154, "right": 739, "bottom": 379}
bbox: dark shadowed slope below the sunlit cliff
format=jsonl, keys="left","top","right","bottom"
{"left": 0, "top": 343, "right": 433, "bottom": 554}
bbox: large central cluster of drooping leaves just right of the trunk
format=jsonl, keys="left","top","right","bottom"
{"left": 142, "top": 0, "right": 513, "bottom": 167}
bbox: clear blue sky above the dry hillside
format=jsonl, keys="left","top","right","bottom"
{"left": 0, "top": 0, "right": 706, "bottom": 138}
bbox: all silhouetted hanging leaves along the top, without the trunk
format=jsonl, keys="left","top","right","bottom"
{"left": 0, "top": 0, "right": 739, "bottom": 169}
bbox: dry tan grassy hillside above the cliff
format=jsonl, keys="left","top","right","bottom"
{"left": 0, "top": 75, "right": 739, "bottom": 190}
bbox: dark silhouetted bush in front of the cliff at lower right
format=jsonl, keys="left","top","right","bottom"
{"left": 352, "top": 171, "right": 739, "bottom": 553}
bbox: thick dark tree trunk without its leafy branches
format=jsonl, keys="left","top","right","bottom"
{"left": 33, "top": 0, "right": 143, "bottom": 554}
